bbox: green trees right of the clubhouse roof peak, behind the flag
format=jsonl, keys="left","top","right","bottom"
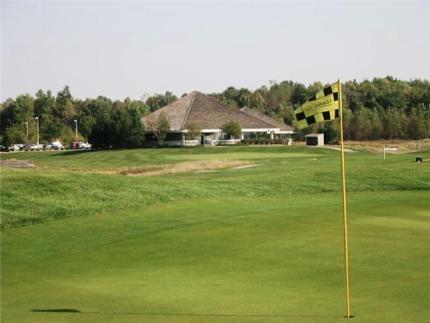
{"left": 212, "top": 76, "right": 430, "bottom": 142}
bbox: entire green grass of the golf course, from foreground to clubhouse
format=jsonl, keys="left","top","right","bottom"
{"left": 1, "top": 146, "right": 430, "bottom": 323}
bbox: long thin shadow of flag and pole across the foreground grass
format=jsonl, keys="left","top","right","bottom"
{"left": 31, "top": 308, "right": 341, "bottom": 319}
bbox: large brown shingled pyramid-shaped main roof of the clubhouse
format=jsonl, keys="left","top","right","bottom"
{"left": 143, "top": 91, "right": 279, "bottom": 131}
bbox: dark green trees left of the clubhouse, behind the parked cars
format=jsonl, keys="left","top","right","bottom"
{"left": 0, "top": 86, "right": 149, "bottom": 148}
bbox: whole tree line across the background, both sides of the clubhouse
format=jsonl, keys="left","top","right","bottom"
{"left": 0, "top": 76, "right": 430, "bottom": 148}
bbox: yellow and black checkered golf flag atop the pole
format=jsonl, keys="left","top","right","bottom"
{"left": 294, "top": 82, "right": 339, "bottom": 129}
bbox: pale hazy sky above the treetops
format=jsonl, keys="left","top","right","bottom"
{"left": 0, "top": 1, "right": 430, "bottom": 101}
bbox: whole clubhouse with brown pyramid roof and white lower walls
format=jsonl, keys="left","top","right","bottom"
{"left": 143, "top": 91, "right": 293, "bottom": 146}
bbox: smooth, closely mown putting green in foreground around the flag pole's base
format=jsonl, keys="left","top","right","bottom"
{"left": 2, "top": 192, "right": 430, "bottom": 322}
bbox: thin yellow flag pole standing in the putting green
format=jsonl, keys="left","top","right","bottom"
{"left": 337, "top": 79, "right": 353, "bottom": 318}
